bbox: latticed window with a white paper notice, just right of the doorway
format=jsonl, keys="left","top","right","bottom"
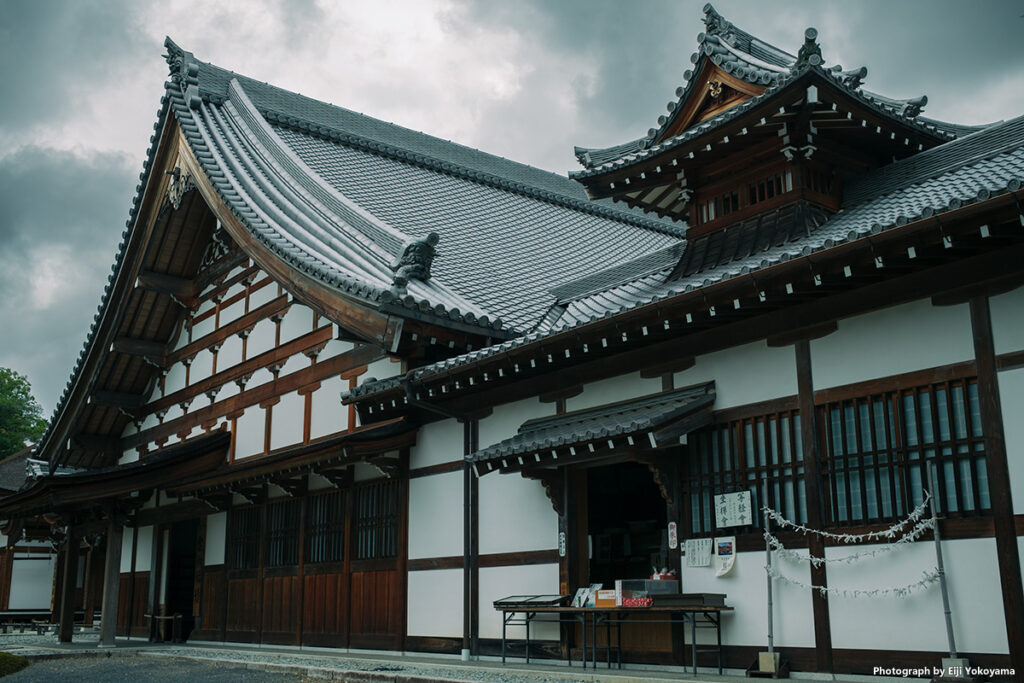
{"left": 683, "top": 411, "right": 807, "bottom": 535}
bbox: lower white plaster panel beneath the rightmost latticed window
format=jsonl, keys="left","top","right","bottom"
{"left": 825, "top": 539, "right": 1009, "bottom": 654}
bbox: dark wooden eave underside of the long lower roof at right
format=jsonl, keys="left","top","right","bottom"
{"left": 356, "top": 196, "right": 1024, "bottom": 423}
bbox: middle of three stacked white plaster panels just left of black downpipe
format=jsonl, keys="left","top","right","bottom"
{"left": 409, "top": 472, "right": 460, "bottom": 558}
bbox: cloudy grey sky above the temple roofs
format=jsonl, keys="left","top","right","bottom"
{"left": 0, "top": 0, "right": 1024, "bottom": 415}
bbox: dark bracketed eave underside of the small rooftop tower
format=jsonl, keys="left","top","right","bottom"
{"left": 581, "top": 73, "right": 946, "bottom": 220}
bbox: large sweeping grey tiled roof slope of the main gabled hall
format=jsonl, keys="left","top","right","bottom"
{"left": 168, "top": 42, "right": 682, "bottom": 330}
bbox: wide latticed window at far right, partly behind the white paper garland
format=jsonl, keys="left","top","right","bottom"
{"left": 818, "top": 379, "right": 990, "bottom": 524}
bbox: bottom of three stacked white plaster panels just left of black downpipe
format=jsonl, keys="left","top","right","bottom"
{"left": 408, "top": 569, "right": 462, "bottom": 637}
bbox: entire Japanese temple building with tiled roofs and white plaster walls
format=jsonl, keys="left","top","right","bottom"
{"left": 0, "top": 5, "right": 1024, "bottom": 674}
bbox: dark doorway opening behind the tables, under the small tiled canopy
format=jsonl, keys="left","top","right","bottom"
{"left": 587, "top": 462, "right": 669, "bottom": 588}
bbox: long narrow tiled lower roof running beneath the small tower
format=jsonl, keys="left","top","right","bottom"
{"left": 347, "top": 117, "right": 1024, "bottom": 398}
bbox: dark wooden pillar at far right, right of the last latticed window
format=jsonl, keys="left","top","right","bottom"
{"left": 971, "top": 296, "right": 1024, "bottom": 673}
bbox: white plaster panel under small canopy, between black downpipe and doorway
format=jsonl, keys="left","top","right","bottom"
{"left": 479, "top": 473, "right": 558, "bottom": 554}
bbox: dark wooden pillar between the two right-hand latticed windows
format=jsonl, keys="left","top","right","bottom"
{"left": 790, "top": 339, "right": 833, "bottom": 672}
